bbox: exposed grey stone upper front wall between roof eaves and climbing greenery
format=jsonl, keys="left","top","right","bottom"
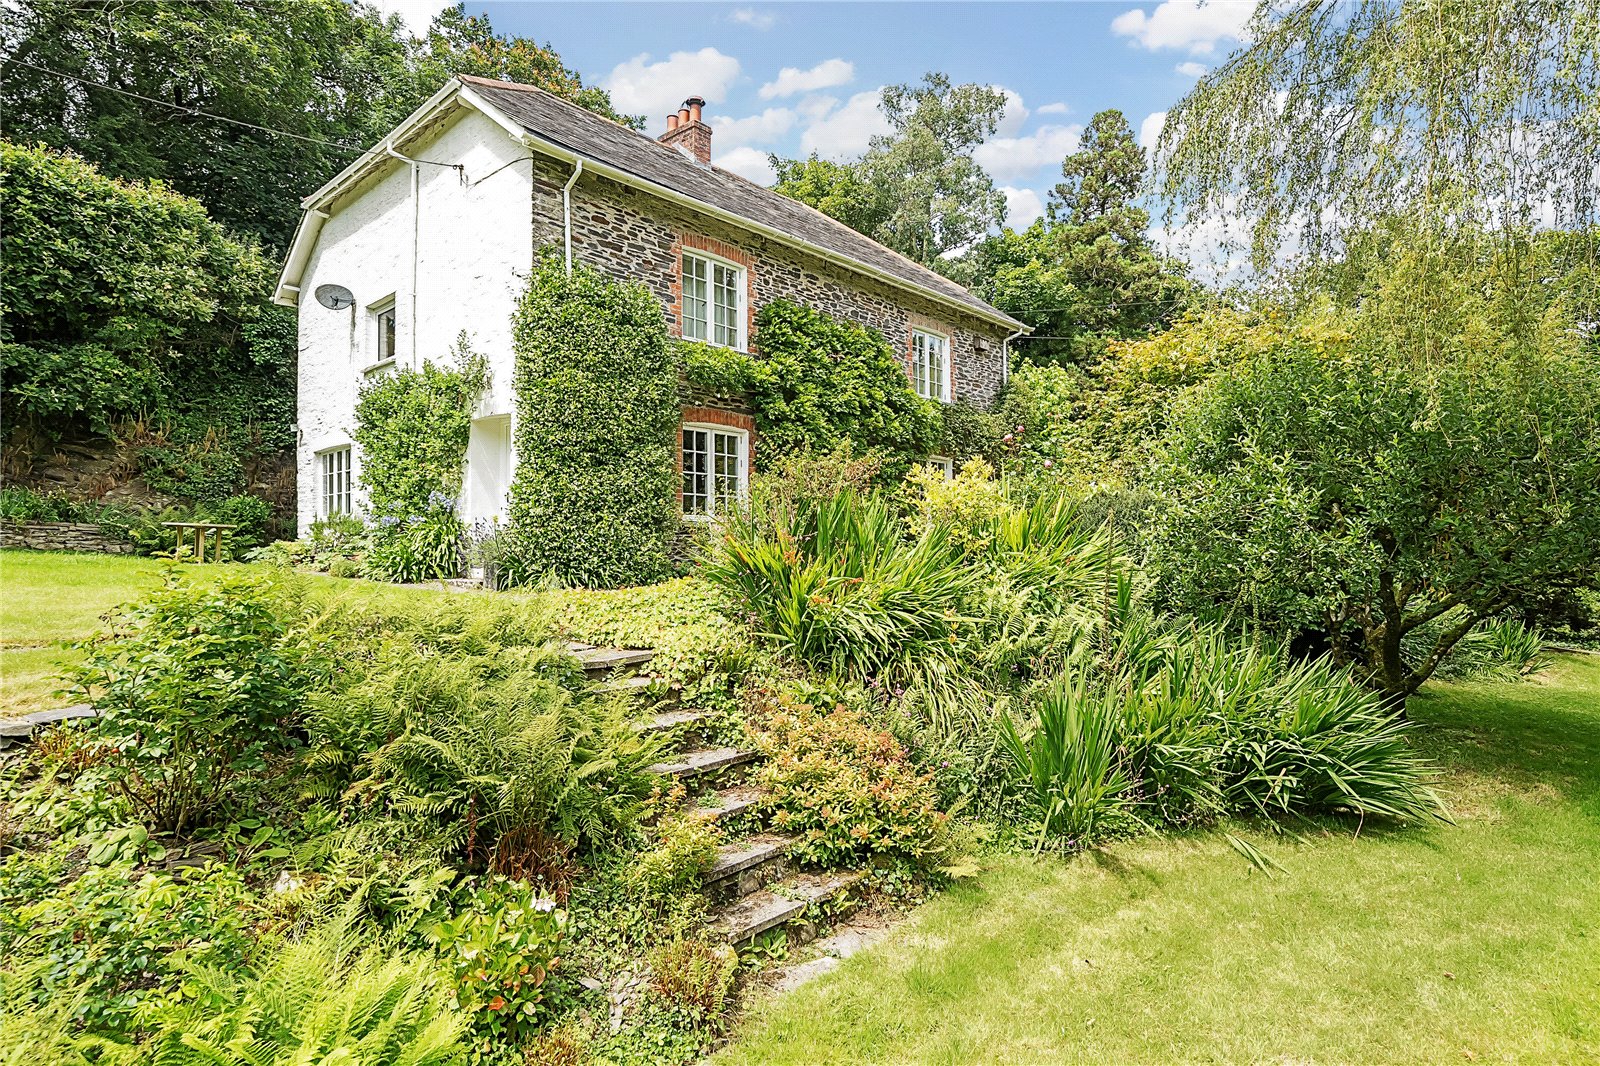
{"left": 533, "top": 162, "right": 1006, "bottom": 408}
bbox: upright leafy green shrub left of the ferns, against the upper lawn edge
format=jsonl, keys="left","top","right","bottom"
{"left": 74, "top": 570, "right": 323, "bottom": 834}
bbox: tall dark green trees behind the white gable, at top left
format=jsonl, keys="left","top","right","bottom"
{"left": 0, "top": 0, "right": 636, "bottom": 248}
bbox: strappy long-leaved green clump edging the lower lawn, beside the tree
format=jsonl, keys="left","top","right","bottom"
{"left": 1003, "top": 605, "right": 1443, "bottom": 847}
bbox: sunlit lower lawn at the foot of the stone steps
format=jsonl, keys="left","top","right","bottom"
{"left": 717, "top": 656, "right": 1600, "bottom": 1066}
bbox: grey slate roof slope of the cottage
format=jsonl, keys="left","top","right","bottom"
{"left": 456, "top": 74, "right": 1022, "bottom": 328}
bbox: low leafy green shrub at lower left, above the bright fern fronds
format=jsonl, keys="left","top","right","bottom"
{"left": 6, "top": 864, "right": 254, "bottom": 1032}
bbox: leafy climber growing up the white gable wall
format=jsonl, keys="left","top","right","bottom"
{"left": 345, "top": 333, "right": 488, "bottom": 581}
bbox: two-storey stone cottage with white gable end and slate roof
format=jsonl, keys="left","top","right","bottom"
{"left": 275, "top": 75, "right": 1024, "bottom": 528}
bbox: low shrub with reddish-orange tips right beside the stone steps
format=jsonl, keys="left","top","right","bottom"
{"left": 750, "top": 685, "right": 949, "bottom": 866}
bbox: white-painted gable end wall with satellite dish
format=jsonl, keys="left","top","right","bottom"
{"left": 298, "top": 109, "right": 533, "bottom": 533}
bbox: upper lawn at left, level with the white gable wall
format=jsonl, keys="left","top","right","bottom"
{"left": 0, "top": 551, "right": 460, "bottom": 717}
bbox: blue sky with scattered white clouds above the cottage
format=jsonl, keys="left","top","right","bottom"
{"left": 378, "top": 0, "right": 1254, "bottom": 227}
